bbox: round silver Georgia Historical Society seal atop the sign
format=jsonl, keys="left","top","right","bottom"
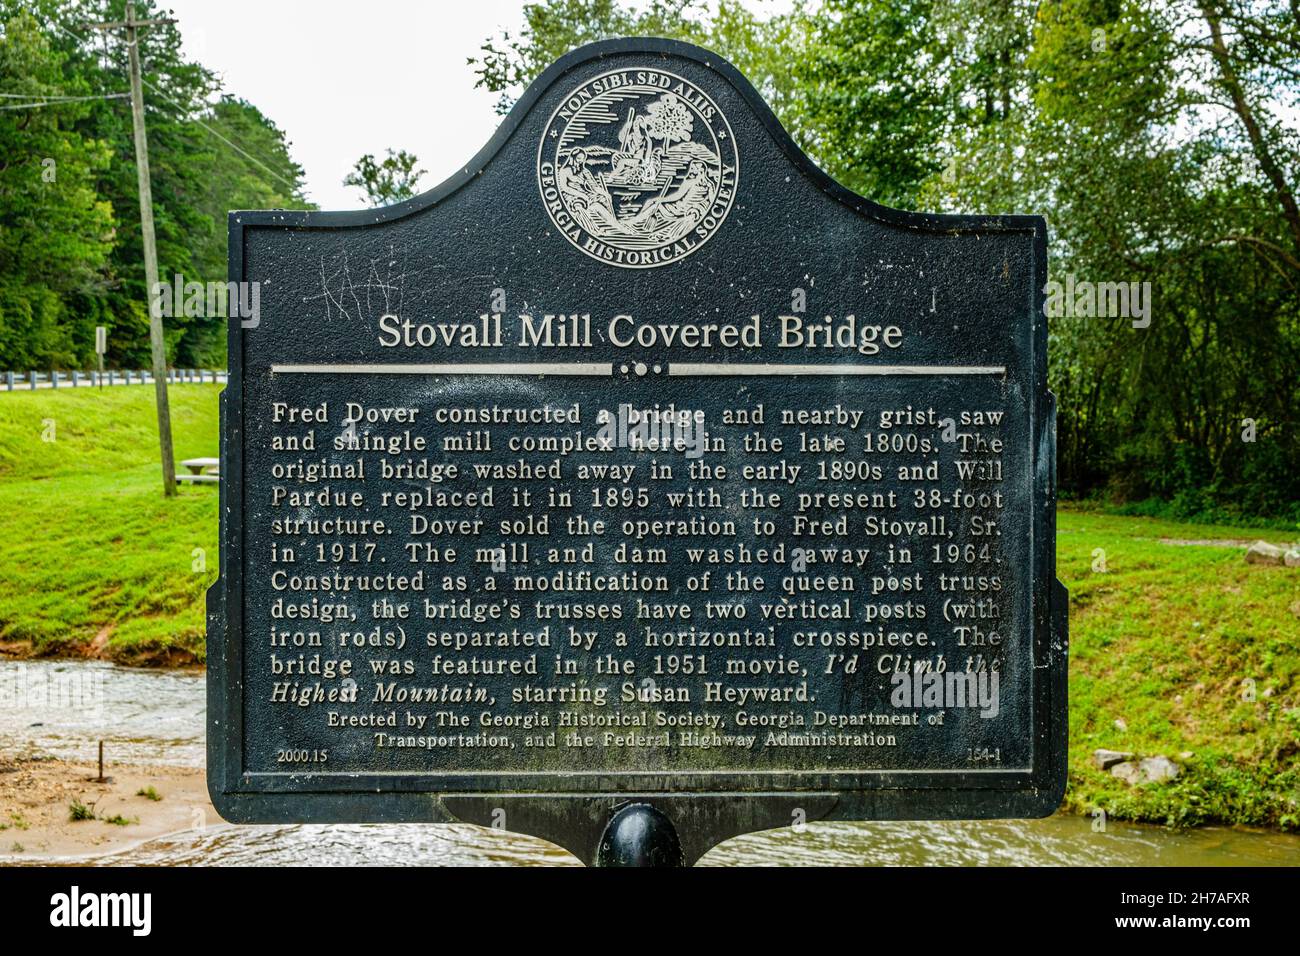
{"left": 537, "top": 69, "right": 740, "bottom": 269}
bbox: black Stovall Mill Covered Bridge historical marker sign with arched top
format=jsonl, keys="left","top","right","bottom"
{"left": 208, "top": 40, "right": 1066, "bottom": 858}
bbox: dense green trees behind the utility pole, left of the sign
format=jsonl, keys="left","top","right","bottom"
{"left": 0, "top": 0, "right": 306, "bottom": 369}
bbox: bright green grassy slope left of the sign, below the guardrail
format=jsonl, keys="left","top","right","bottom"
{"left": 0, "top": 385, "right": 221, "bottom": 663}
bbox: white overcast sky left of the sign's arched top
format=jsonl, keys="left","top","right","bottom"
{"left": 160, "top": 0, "right": 788, "bottom": 209}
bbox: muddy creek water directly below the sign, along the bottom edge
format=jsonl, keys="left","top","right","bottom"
{"left": 105, "top": 816, "right": 1300, "bottom": 866}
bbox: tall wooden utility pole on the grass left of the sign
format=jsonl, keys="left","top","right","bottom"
{"left": 95, "top": 0, "right": 176, "bottom": 496}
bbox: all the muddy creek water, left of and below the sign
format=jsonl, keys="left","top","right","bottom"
{"left": 0, "top": 662, "right": 1300, "bottom": 866}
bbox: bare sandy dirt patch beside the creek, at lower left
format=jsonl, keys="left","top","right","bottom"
{"left": 0, "top": 756, "right": 220, "bottom": 864}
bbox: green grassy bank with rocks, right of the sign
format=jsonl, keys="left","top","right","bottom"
{"left": 1057, "top": 511, "right": 1300, "bottom": 830}
